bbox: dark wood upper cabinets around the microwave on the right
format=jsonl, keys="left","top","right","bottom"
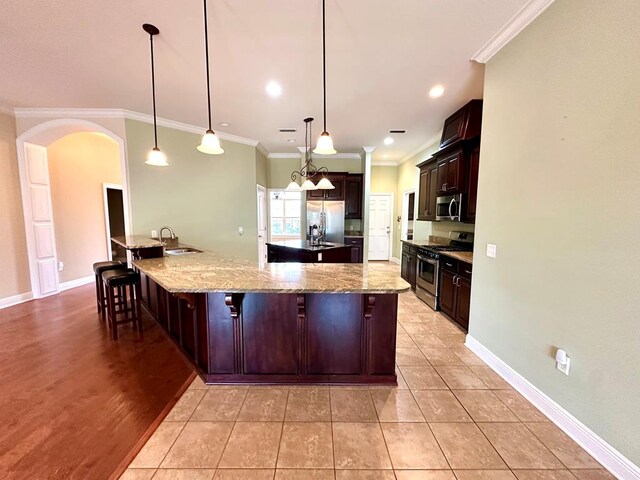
{"left": 418, "top": 100, "right": 482, "bottom": 223}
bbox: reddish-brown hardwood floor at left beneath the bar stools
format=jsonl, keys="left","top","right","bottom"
{"left": 0, "top": 285, "right": 194, "bottom": 480}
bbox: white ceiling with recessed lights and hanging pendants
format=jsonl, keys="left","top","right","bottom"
{"left": 0, "top": 0, "right": 527, "bottom": 162}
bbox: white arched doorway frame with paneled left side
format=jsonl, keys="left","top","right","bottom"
{"left": 16, "top": 119, "right": 131, "bottom": 298}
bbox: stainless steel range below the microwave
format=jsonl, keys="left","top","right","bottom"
{"left": 416, "top": 232, "right": 473, "bottom": 310}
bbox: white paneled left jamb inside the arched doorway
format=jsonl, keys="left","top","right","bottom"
{"left": 21, "top": 143, "right": 58, "bottom": 298}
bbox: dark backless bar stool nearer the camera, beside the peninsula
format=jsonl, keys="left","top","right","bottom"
{"left": 102, "top": 268, "right": 142, "bottom": 340}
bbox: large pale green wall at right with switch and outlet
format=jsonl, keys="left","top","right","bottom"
{"left": 469, "top": 0, "right": 640, "bottom": 465}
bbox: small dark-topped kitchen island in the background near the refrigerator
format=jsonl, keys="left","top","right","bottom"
{"left": 267, "top": 240, "right": 351, "bottom": 263}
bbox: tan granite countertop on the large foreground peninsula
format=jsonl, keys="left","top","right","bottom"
{"left": 133, "top": 252, "right": 410, "bottom": 294}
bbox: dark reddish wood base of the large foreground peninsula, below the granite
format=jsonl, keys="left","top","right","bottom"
{"left": 141, "top": 273, "right": 398, "bottom": 385}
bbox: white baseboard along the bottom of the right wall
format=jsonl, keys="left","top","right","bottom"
{"left": 465, "top": 335, "right": 640, "bottom": 480}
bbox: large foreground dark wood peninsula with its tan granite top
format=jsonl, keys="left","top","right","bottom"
{"left": 134, "top": 252, "right": 409, "bottom": 385}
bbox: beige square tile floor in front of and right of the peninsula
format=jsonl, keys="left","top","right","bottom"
{"left": 120, "top": 265, "right": 614, "bottom": 480}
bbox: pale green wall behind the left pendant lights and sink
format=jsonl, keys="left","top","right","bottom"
{"left": 125, "top": 120, "right": 259, "bottom": 260}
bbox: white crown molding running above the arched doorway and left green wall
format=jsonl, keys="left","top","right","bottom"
{"left": 14, "top": 108, "right": 260, "bottom": 148}
